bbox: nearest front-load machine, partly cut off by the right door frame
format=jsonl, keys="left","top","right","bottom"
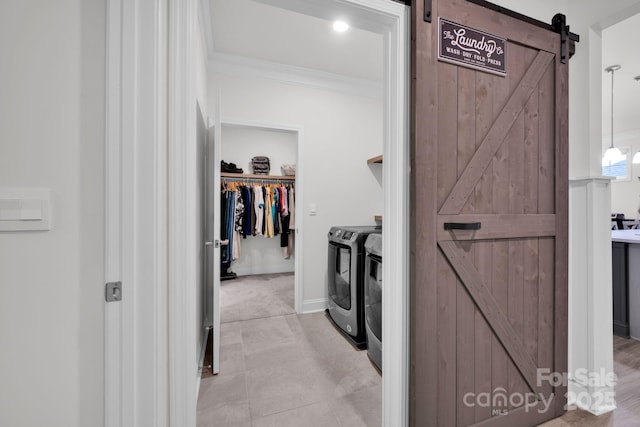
{"left": 364, "top": 234, "right": 382, "bottom": 372}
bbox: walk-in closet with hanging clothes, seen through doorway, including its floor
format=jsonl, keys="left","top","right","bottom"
{"left": 219, "top": 123, "right": 298, "bottom": 324}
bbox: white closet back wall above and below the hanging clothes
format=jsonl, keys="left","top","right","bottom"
{"left": 221, "top": 124, "right": 298, "bottom": 276}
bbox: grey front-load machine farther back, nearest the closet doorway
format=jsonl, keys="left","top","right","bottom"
{"left": 327, "top": 226, "right": 382, "bottom": 349}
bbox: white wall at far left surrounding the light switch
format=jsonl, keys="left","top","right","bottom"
{"left": 0, "top": 0, "right": 106, "bottom": 427}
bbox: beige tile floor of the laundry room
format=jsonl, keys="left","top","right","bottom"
{"left": 197, "top": 276, "right": 382, "bottom": 427}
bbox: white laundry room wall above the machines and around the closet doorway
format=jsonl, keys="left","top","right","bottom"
{"left": 210, "top": 74, "right": 383, "bottom": 302}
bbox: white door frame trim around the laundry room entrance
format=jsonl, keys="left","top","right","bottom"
{"left": 105, "top": 0, "right": 410, "bottom": 427}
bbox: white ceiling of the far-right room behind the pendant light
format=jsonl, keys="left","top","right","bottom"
{"left": 602, "top": 15, "right": 640, "bottom": 140}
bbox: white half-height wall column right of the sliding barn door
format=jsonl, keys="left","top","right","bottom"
{"left": 568, "top": 177, "right": 615, "bottom": 415}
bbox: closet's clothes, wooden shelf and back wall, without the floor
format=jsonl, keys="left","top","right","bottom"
{"left": 220, "top": 124, "right": 297, "bottom": 280}
